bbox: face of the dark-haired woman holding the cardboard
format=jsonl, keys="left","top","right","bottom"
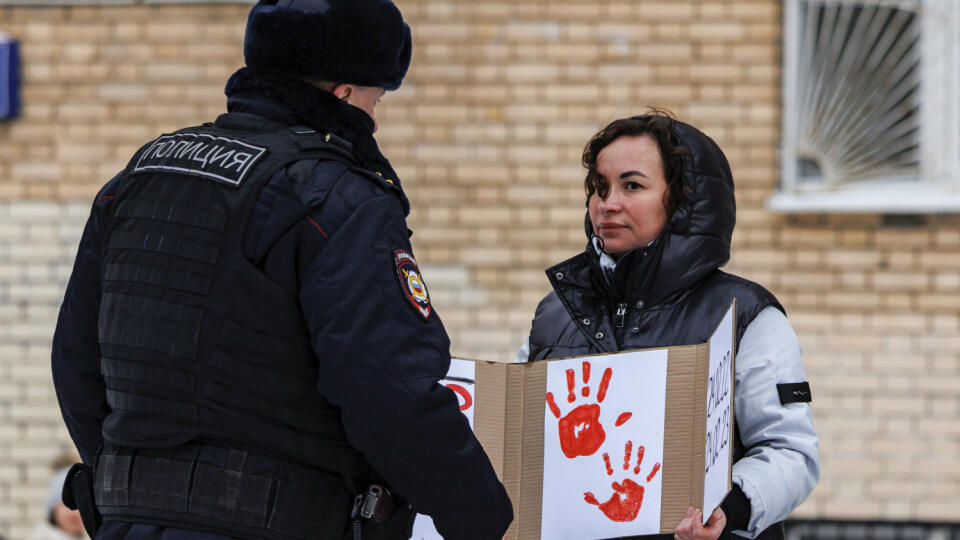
{"left": 589, "top": 135, "right": 668, "bottom": 255}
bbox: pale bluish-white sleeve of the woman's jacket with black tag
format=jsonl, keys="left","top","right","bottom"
{"left": 733, "top": 307, "right": 820, "bottom": 538}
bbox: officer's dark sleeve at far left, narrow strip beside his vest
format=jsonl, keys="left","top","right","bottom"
{"left": 51, "top": 184, "right": 112, "bottom": 464}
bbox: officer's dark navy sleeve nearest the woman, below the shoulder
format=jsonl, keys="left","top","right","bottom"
{"left": 300, "top": 193, "right": 513, "bottom": 539}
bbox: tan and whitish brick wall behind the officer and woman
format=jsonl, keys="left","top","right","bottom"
{"left": 0, "top": 0, "right": 960, "bottom": 538}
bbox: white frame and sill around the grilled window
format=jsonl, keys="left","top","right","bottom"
{"left": 767, "top": 0, "right": 960, "bottom": 214}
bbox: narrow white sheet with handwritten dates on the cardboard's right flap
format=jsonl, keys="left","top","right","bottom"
{"left": 702, "top": 307, "right": 734, "bottom": 523}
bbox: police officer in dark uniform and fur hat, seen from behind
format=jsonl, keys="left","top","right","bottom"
{"left": 53, "top": 0, "right": 512, "bottom": 539}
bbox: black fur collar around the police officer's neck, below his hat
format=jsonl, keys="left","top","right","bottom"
{"left": 226, "top": 68, "right": 400, "bottom": 187}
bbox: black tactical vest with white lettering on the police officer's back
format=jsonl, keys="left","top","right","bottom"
{"left": 96, "top": 125, "right": 378, "bottom": 538}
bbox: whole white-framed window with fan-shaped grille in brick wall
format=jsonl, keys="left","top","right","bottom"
{"left": 768, "top": 0, "right": 960, "bottom": 213}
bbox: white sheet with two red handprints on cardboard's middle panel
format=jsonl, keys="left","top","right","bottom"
{"left": 540, "top": 349, "right": 667, "bottom": 540}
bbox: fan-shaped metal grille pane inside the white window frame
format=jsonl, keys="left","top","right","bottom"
{"left": 784, "top": 0, "right": 921, "bottom": 190}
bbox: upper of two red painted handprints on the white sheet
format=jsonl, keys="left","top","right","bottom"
{"left": 547, "top": 362, "right": 630, "bottom": 458}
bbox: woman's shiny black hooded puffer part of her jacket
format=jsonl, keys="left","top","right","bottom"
{"left": 529, "top": 122, "right": 783, "bottom": 538}
